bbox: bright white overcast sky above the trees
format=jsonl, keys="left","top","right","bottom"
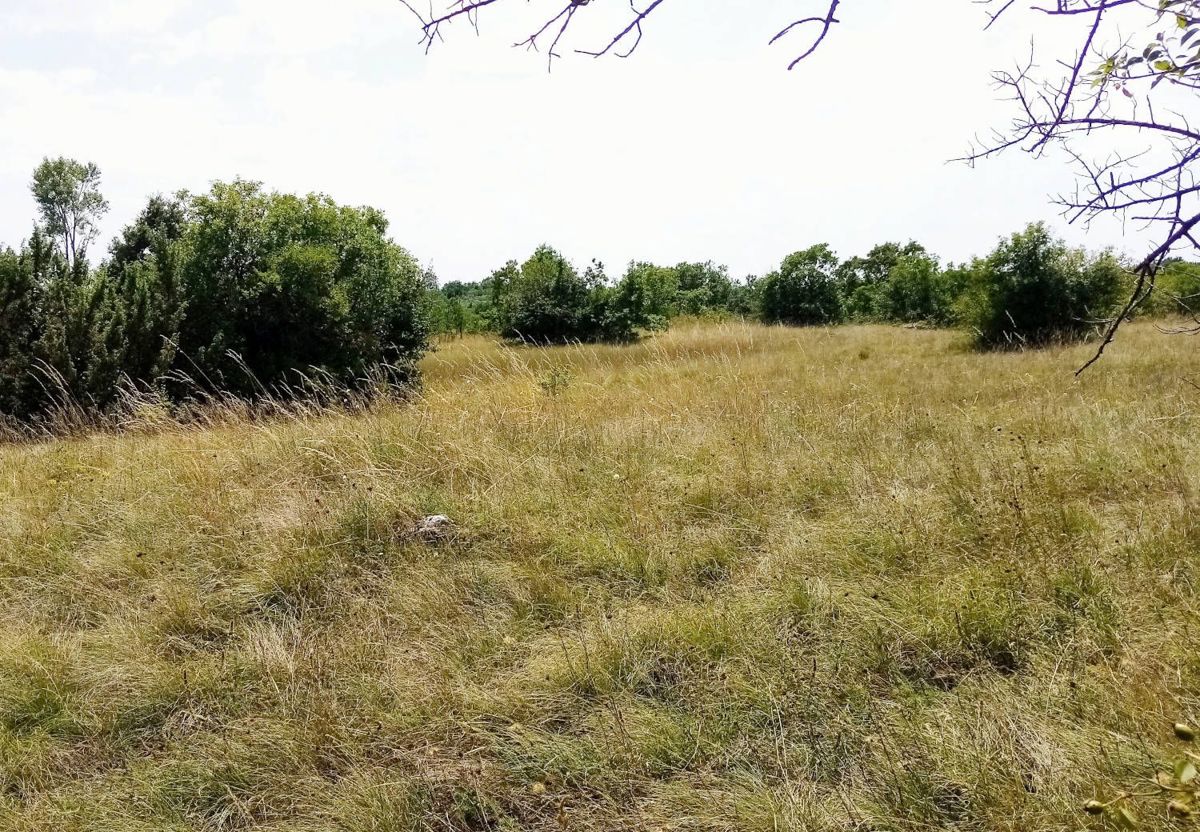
{"left": 0, "top": 0, "right": 1133, "bottom": 281}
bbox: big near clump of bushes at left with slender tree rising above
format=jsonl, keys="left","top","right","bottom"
{"left": 0, "top": 158, "right": 427, "bottom": 420}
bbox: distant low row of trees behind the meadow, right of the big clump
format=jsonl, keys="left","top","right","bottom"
{"left": 431, "top": 225, "right": 1137, "bottom": 348}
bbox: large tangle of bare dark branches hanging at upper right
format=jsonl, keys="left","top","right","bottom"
{"left": 965, "top": 0, "right": 1200, "bottom": 372}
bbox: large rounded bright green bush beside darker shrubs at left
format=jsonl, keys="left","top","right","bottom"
{"left": 180, "top": 180, "right": 426, "bottom": 394}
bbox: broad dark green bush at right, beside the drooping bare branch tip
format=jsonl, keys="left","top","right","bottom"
{"left": 962, "top": 223, "right": 1126, "bottom": 347}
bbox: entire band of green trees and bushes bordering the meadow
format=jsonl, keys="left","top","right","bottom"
{"left": 0, "top": 158, "right": 1200, "bottom": 423}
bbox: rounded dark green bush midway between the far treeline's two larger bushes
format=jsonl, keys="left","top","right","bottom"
{"left": 760, "top": 244, "right": 845, "bottom": 327}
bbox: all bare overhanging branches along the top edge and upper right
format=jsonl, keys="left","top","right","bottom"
{"left": 400, "top": 0, "right": 1200, "bottom": 370}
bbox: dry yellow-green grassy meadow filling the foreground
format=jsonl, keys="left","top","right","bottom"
{"left": 0, "top": 325, "right": 1200, "bottom": 832}
